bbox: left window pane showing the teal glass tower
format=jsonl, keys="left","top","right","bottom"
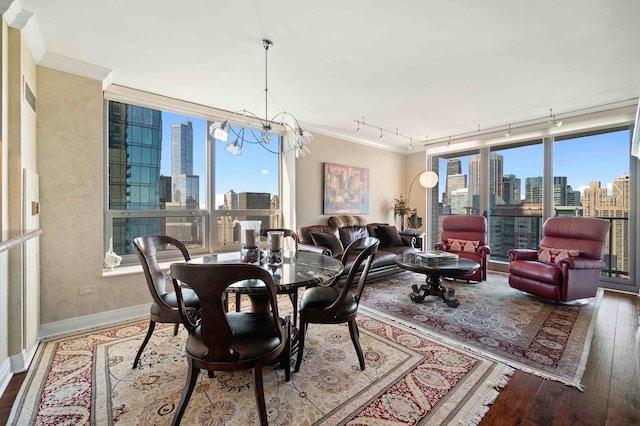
{"left": 105, "top": 101, "right": 207, "bottom": 261}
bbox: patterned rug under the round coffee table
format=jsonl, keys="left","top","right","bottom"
{"left": 361, "top": 271, "right": 603, "bottom": 390}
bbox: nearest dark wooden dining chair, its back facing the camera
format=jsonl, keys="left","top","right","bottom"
{"left": 171, "top": 263, "right": 291, "bottom": 425}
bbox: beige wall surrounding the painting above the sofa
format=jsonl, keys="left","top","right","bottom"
{"left": 296, "top": 134, "right": 405, "bottom": 228}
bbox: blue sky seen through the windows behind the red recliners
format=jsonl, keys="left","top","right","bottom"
{"left": 439, "top": 130, "right": 630, "bottom": 201}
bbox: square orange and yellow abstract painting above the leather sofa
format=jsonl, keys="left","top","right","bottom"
{"left": 324, "top": 163, "right": 369, "bottom": 214}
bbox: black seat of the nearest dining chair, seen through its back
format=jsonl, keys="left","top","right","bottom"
{"left": 186, "top": 312, "right": 280, "bottom": 360}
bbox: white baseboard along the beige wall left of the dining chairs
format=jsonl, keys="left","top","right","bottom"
{"left": 38, "top": 303, "right": 150, "bottom": 341}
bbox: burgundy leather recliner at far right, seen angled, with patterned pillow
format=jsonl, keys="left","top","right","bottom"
{"left": 508, "top": 217, "right": 609, "bottom": 302}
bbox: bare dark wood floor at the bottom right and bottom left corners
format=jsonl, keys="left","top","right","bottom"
{"left": 0, "top": 291, "right": 640, "bottom": 426}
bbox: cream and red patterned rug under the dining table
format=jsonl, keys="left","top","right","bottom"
{"left": 10, "top": 314, "right": 514, "bottom": 425}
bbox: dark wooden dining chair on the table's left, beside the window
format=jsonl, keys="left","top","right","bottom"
{"left": 131, "top": 235, "right": 200, "bottom": 368}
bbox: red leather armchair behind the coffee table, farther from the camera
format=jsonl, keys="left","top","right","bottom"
{"left": 434, "top": 215, "right": 491, "bottom": 281}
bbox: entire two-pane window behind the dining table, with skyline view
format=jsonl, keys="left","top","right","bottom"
{"left": 105, "top": 100, "right": 281, "bottom": 263}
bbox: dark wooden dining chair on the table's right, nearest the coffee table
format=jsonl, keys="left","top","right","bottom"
{"left": 294, "top": 237, "right": 380, "bottom": 373}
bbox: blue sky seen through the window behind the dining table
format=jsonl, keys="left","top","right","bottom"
{"left": 160, "top": 111, "right": 279, "bottom": 208}
